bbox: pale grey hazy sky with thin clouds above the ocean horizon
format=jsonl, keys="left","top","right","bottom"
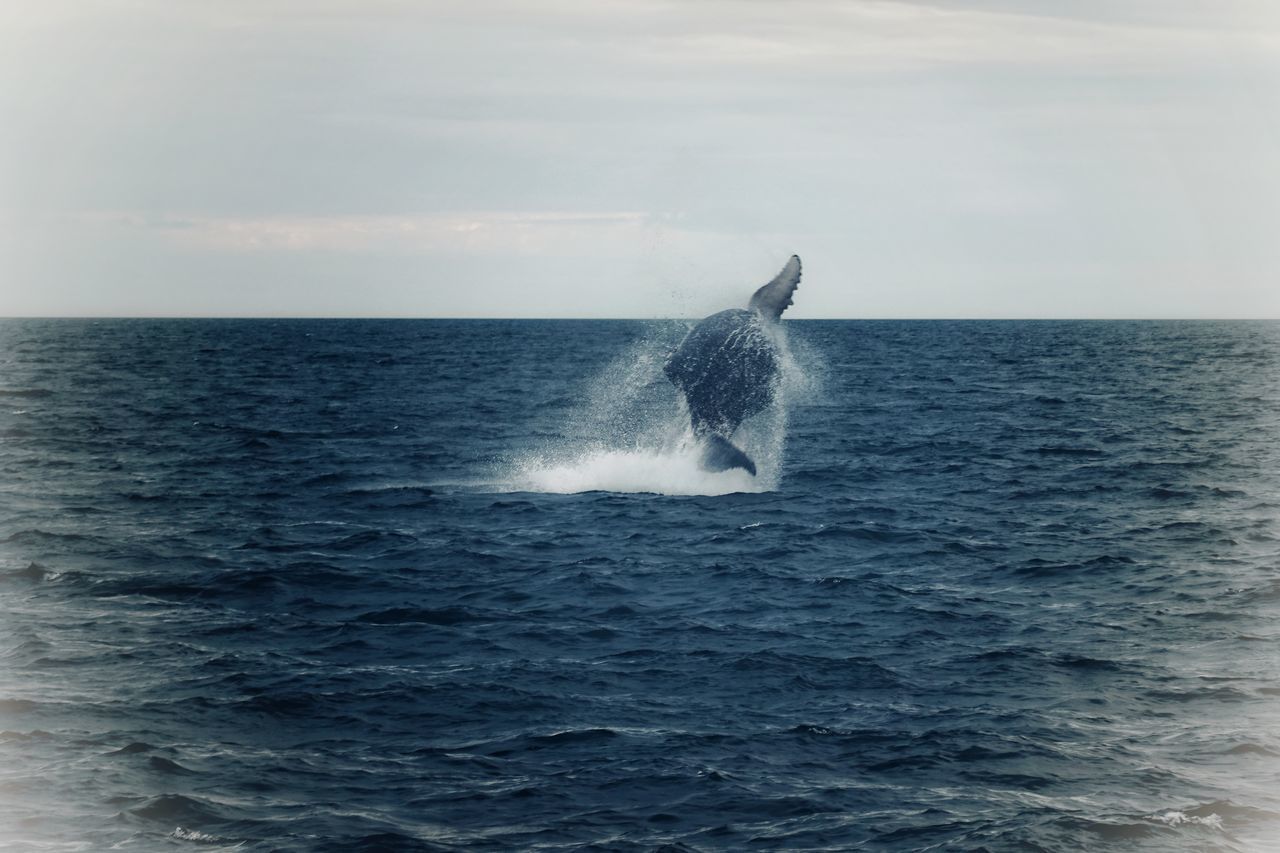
{"left": 0, "top": 0, "right": 1280, "bottom": 318}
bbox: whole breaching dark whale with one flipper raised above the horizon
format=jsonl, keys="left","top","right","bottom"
{"left": 663, "top": 255, "right": 800, "bottom": 474}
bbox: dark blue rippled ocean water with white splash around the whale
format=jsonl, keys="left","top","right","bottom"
{"left": 0, "top": 320, "right": 1280, "bottom": 850}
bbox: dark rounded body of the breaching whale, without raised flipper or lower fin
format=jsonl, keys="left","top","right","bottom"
{"left": 663, "top": 309, "right": 780, "bottom": 435}
